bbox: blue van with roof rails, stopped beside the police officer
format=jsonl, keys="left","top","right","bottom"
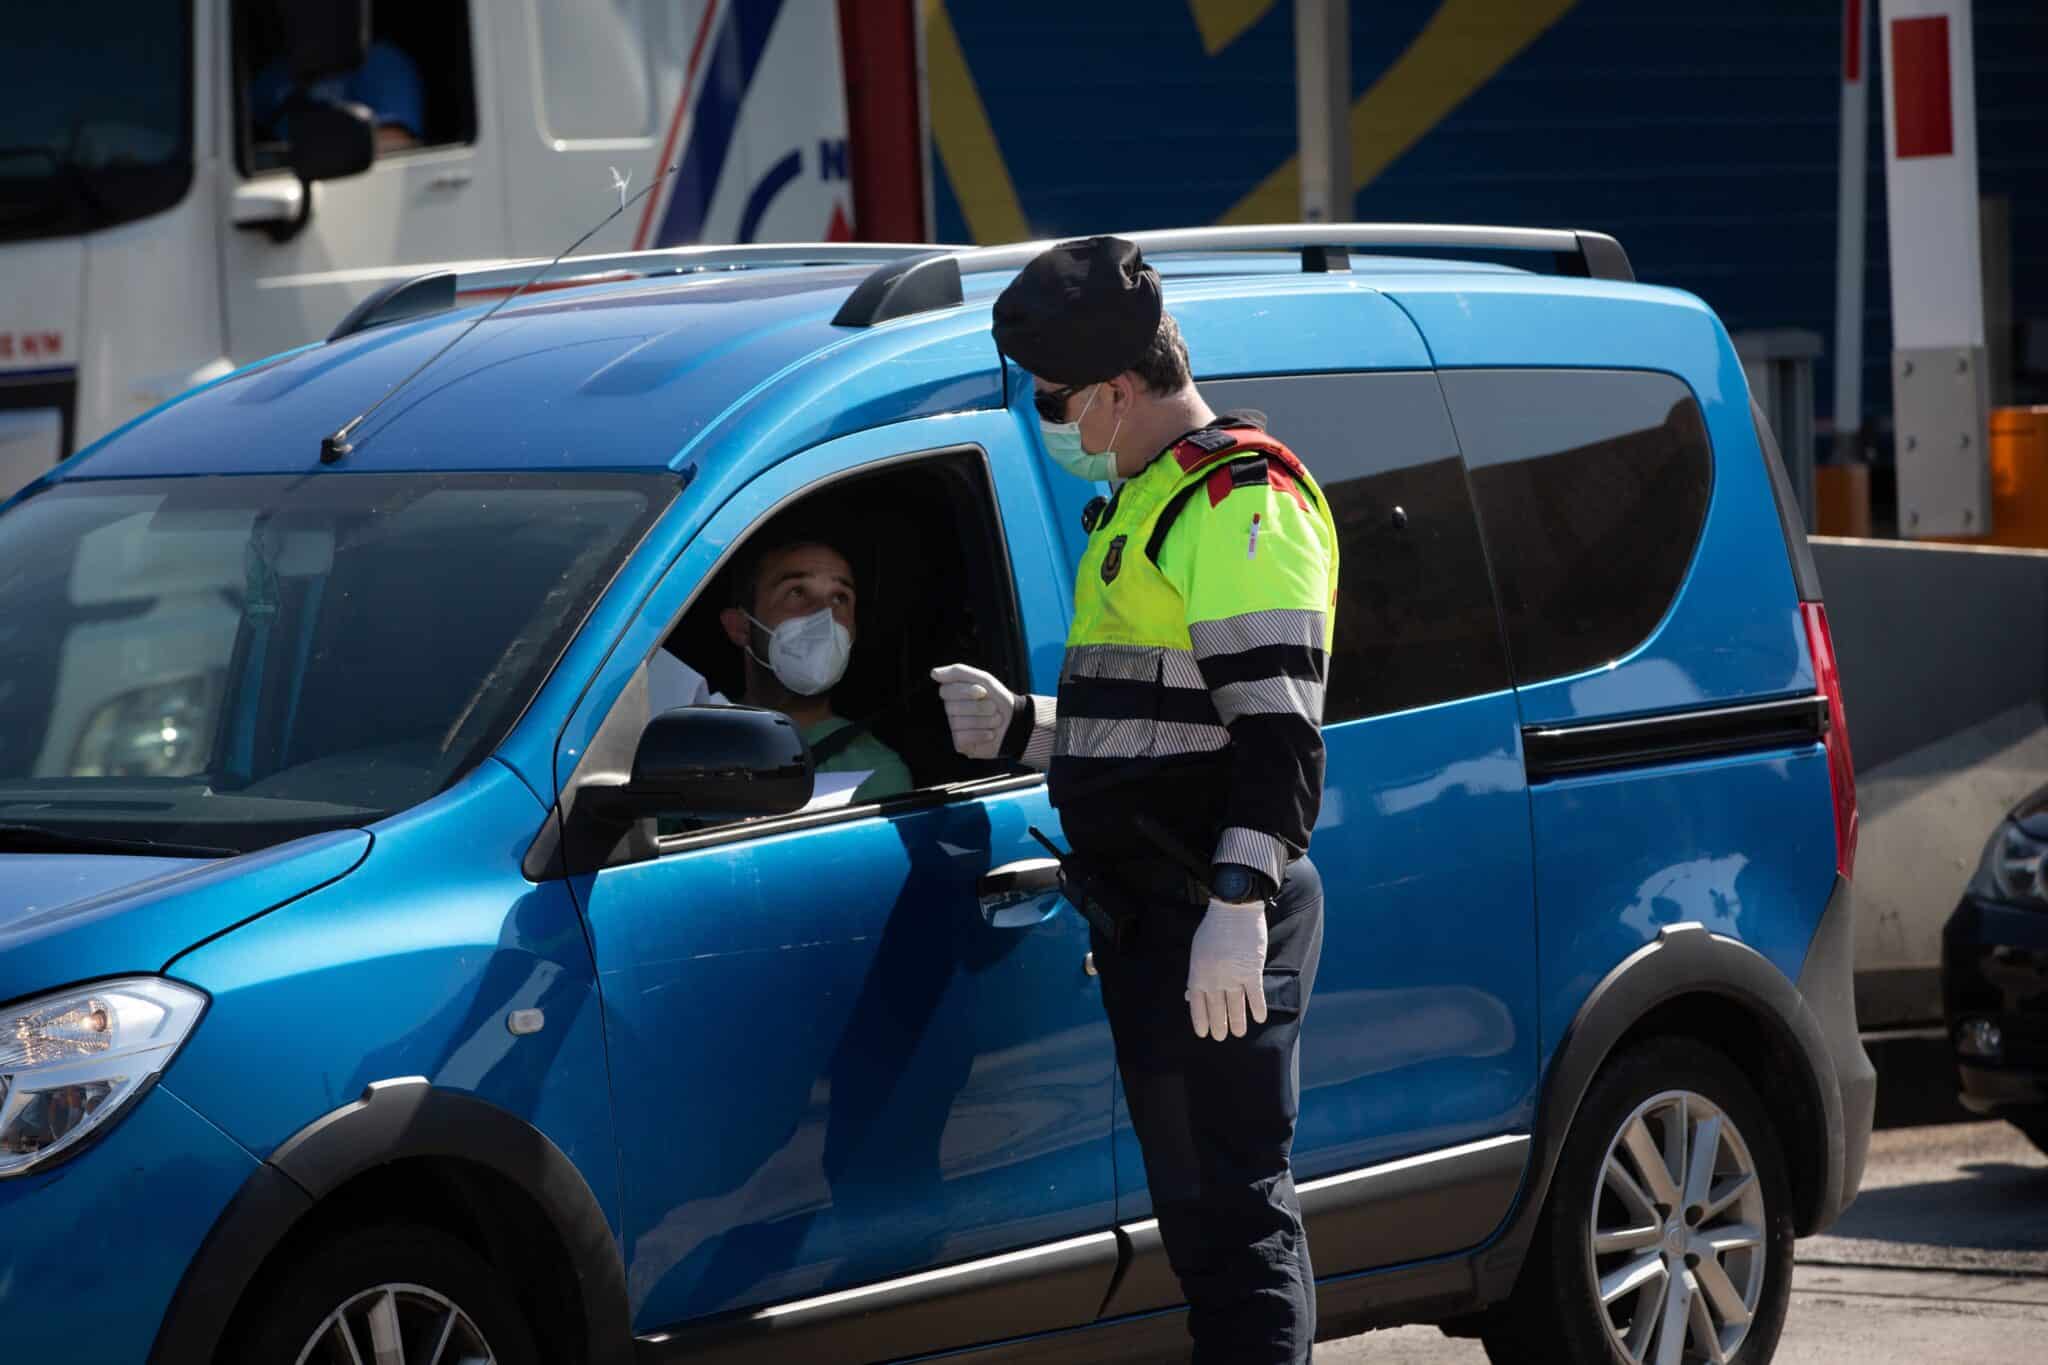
{"left": 0, "top": 225, "right": 1874, "bottom": 1365}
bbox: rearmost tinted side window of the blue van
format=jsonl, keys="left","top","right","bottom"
{"left": 1442, "top": 370, "right": 1714, "bottom": 684}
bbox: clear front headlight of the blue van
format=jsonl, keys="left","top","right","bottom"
{"left": 0, "top": 976, "right": 207, "bottom": 1179}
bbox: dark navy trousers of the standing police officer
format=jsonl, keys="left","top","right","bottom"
{"left": 1096, "top": 857, "right": 1323, "bottom": 1365}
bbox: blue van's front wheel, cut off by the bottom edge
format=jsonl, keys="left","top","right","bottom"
{"left": 221, "top": 1224, "right": 541, "bottom": 1365}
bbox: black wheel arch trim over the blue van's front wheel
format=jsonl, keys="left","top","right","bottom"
{"left": 150, "top": 1076, "right": 633, "bottom": 1365}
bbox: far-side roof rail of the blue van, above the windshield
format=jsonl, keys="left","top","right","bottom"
{"left": 328, "top": 241, "right": 942, "bottom": 342}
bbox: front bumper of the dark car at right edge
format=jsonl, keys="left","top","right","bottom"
{"left": 1942, "top": 896, "right": 2048, "bottom": 1117}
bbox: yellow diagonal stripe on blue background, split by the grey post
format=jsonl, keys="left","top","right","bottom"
{"left": 1217, "top": 0, "right": 1577, "bottom": 223}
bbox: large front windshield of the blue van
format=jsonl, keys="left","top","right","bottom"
{"left": 0, "top": 473, "right": 678, "bottom": 851}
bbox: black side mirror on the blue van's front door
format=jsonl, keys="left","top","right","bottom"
{"left": 602, "top": 706, "right": 813, "bottom": 821}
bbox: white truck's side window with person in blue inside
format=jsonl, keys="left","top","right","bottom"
{"left": 236, "top": 0, "right": 477, "bottom": 174}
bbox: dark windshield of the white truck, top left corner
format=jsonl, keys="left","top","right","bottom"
{"left": 0, "top": 0, "right": 193, "bottom": 241}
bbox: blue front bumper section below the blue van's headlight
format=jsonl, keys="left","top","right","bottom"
{"left": 0, "top": 1085, "right": 256, "bottom": 1361}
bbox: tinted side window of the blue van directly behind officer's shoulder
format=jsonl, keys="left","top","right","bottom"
{"left": 1202, "top": 372, "right": 1507, "bottom": 724}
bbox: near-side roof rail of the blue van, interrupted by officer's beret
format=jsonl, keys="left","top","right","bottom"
{"left": 831, "top": 223, "right": 1636, "bottom": 327}
